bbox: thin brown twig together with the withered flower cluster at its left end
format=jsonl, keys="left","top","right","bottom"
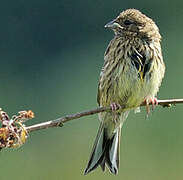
{"left": 0, "top": 99, "right": 183, "bottom": 150}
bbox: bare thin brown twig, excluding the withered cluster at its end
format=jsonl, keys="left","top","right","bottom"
{"left": 25, "top": 99, "right": 183, "bottom": 133}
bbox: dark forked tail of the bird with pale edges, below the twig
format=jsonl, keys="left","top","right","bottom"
{"left": 84, "top": 119, "right": 121, "bottom": 175}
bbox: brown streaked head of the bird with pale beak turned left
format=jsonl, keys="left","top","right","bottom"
{"left": 105, "top": 9, "right": 161, "bottom": 40}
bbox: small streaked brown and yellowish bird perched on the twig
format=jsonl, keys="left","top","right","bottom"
{"left": 84, "top": 9, "right": 165, "bottom": 175}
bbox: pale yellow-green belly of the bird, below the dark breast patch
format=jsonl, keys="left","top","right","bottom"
{"left": 99, "top": 55, "right": 164, "bottom": 109}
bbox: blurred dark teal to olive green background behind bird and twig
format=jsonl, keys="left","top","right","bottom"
{"left": 0, "top": 0, "right": 183, "bottom": 180}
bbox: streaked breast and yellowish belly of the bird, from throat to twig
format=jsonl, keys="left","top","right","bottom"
{"left": 99, "top": 37, "right": 163, "bottom": 108}
